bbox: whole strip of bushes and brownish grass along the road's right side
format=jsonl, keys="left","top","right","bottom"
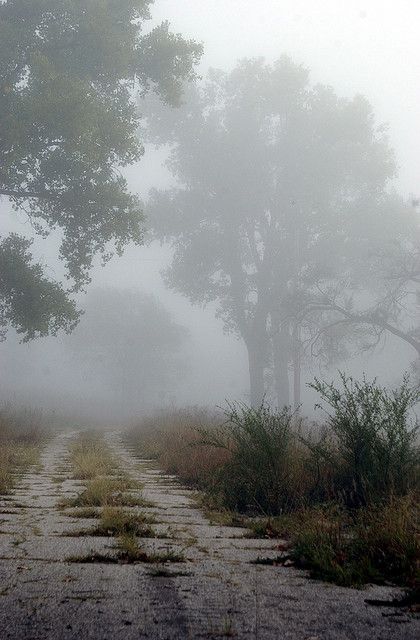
{"left": 129, "top": 376, "right": 420, "bottom": 588}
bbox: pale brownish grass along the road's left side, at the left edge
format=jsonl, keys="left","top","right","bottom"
{"left": 0, "top": 405, "right": 46, "bottom": 494}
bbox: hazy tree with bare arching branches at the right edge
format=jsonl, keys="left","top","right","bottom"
{"left": 295, "top": 216, "right": 420, "bottom": 376}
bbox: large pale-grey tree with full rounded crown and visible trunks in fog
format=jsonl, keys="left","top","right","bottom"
{"left": 144, "top": 57, "right": 405, "bottom": 405}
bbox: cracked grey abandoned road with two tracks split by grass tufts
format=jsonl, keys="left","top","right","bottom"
{"left": 0, "top": 432, "right": 420, "bottom": 640}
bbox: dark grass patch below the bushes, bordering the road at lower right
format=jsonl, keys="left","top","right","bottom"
{"left": 261, "top": 496, "right": 420, "bottom": 588}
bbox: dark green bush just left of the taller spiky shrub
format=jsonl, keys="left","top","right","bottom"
{"left": 200, "top": 403, "right": 303, "bottom": 514}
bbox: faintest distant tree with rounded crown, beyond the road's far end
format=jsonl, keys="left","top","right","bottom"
{"left": 65, "top": 289, "right": 188, "bottom": 414}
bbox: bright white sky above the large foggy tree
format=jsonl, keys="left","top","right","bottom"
{"left": 153, "top": 0, "right": 420, "bottom": 195}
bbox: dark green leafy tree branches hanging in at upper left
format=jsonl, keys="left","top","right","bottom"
{"left": 0, "top": 0, "right": 201, "bottom": 339}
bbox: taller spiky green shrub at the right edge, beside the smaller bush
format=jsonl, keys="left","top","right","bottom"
{"left": 306, "top": 374, "right": 420, "bottom": 506}
